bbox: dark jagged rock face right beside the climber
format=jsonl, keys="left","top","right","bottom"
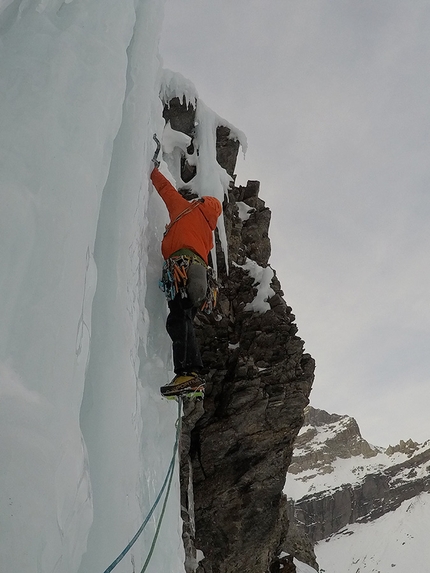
{"left": 161, "top": 96, "right": 315, "bottom": 573}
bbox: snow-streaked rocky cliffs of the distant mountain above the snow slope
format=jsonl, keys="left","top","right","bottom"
{"left": 286, "top": 407, "right": 430, "bottom": 570}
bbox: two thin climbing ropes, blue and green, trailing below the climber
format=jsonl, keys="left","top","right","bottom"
{"left": 104, "top": 397, "right": 182, "bottom": 573}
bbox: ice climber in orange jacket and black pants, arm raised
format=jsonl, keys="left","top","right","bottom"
{"left": 151, "top": 137, "right": 222, "bottom": 396}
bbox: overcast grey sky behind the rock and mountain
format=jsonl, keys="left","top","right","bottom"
{"left": 160, "top": 0, "right": 430, "bottom": 446}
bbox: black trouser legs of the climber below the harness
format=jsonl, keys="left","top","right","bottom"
{"left": 166, "top": 294, "right": 203, "bottom": 374}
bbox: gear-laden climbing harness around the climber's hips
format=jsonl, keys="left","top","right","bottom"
{"left": 159, "top": 255, "right": 218, "bottom": 314}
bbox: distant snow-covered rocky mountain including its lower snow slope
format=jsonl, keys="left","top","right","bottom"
{"left": 286, "top": 407, "right": 430, "bottom": 573}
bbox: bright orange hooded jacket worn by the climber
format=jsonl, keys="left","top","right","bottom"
{"left": 151, "top": 168, "right": 222, "bottom": 263}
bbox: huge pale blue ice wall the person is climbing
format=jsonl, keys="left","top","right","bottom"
{"left": 0, "top": 0, "right": 242, "bottom": 573}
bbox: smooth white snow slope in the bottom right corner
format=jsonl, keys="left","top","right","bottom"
{"left": 315, "top": 493, "right": 430, "bottom": 573}
